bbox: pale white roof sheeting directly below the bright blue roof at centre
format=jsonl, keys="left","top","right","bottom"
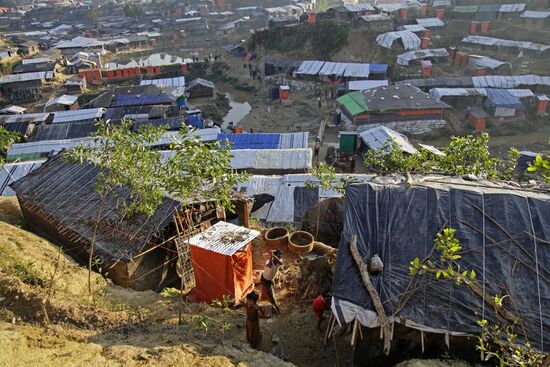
{"left": 231, "top": 148, "right": 312, "bottom": 170}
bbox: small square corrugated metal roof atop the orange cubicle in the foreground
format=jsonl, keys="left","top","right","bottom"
{"left": 189, "top": 222, "right": 260, "bottom": 256}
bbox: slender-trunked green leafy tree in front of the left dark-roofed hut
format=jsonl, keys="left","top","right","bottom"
{"left": 64, "top": 120, "right": 245, "bottom": 296}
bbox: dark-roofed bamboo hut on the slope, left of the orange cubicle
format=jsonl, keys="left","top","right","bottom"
{"left": 10, "top": 155, "right": 252, "bottom": 290}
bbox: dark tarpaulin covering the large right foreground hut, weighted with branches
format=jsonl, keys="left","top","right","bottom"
{"left": 333, "top": 176, "right": 550, "bottom": 352}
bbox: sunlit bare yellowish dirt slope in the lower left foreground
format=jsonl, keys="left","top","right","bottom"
{"left": 0, "top": 198, "right": 291, "bottom": 366}
